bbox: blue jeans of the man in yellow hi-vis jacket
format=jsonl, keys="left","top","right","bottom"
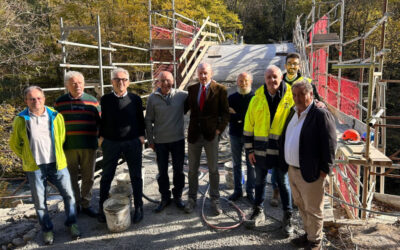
{"left": 254, "top": 165, "right": 293, "bottom": 212}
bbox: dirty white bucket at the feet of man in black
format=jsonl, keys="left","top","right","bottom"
{"left": 103, "top": 196, "right": 131, "bottom": 232}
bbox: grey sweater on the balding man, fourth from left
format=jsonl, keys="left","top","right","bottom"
{"left": 145, "top": 89, "right": 187, "bottom": 144}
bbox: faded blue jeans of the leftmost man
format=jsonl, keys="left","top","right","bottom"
{"left": 25, "top": 163, "right": 76, "bottom": 232}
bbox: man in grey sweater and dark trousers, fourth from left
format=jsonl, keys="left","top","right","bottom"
{"left": 145, "top": 71, "right": 188, "bottom": 213}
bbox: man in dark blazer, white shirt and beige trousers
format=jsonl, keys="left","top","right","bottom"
{"left": 280, "top": 80, "right": 336, "bottom": 249}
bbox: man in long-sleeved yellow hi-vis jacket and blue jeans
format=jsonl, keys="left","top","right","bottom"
{"left": 243, "top": 65, "right": 294, "bottom": 235}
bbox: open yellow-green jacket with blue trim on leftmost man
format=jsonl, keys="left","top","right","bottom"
{"left": 10, "top": 106, "right": 67, "bottom": 172}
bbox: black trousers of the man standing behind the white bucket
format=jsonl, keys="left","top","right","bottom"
{"left": 99, "top": 138, "right": 143, "bottom": 212}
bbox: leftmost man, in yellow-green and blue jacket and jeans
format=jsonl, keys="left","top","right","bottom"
{"left": 10, "top": 86, "right": 81, "bottom": 245}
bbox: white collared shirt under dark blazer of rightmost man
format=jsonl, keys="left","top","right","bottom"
{"left": 285, "top": 103, "right": 313, "bottom": 168}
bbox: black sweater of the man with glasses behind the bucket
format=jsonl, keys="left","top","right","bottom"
{"left": 100, "top": 93, "right": 145, "bottom": 141}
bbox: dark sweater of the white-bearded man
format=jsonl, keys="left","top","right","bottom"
{"left": 228, "top": 91, "right": 254, "bottom": 137}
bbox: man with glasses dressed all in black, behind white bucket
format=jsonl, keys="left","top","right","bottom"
{"left": 98, "top": 68, "right": 145, "bottom": 223}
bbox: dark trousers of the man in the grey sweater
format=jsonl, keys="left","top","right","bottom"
{"left": 155, "top": 139, "right": 185, "bottom": 200}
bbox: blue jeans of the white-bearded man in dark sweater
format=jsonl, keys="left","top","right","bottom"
{"left": 229, "top": 135, "right": 255, "bottom": 196}
